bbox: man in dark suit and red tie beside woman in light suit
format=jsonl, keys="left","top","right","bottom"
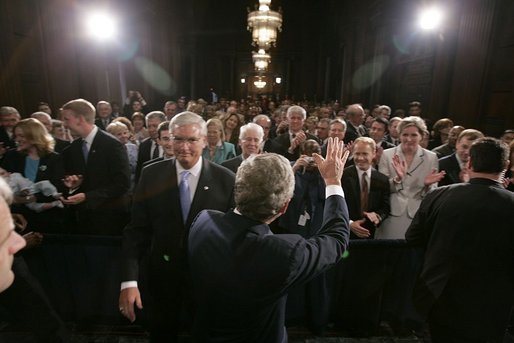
{"left": 343, "top": 137, "right": 390, "bottom": 238}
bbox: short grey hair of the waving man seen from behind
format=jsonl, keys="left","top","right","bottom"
{"left": 234, "top": 153, "right": 294, "bottom": 222}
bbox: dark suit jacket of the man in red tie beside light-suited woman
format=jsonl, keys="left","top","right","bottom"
{"left": 343, "top": 166, "right": 391, "bottom": 239}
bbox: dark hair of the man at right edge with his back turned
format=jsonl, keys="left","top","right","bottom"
{"left": 469, "top": 137, "right": 509, "bottom": 174}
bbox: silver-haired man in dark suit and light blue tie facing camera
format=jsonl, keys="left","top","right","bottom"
{"left": 119, "top": 112, "right": 234, "bottom": 342}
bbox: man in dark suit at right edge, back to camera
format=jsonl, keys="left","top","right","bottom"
{"left": 405, "top": 138, "right": 514, "bottom": 343}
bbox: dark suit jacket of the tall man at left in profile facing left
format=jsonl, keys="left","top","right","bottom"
{"left": 63, "top": 130, "right": 130, "bottom": 234}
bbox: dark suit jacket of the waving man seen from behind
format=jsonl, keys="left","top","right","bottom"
{"left": 189, "top": 195, "right": 349, "bottom": 343}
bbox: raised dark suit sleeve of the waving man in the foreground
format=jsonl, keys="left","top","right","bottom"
{"left": 287, "top": 195, "right": 350, "bottom": 285}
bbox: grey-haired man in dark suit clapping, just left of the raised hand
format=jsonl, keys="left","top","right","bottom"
{"left": 272, "top": 106, "right": 319, "bottom": 161}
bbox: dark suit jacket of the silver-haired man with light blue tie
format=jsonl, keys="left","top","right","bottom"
{"left": 121, "top": 158, "right": 235, "bottom": 292}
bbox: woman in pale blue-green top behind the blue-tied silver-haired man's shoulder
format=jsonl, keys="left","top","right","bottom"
{"left": 202, "top": 118, "right": 236, "bottom": 164}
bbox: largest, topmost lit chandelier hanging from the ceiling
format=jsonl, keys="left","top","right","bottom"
{"left": 247, "top": 0, "right": 282, "bottom": 49}
